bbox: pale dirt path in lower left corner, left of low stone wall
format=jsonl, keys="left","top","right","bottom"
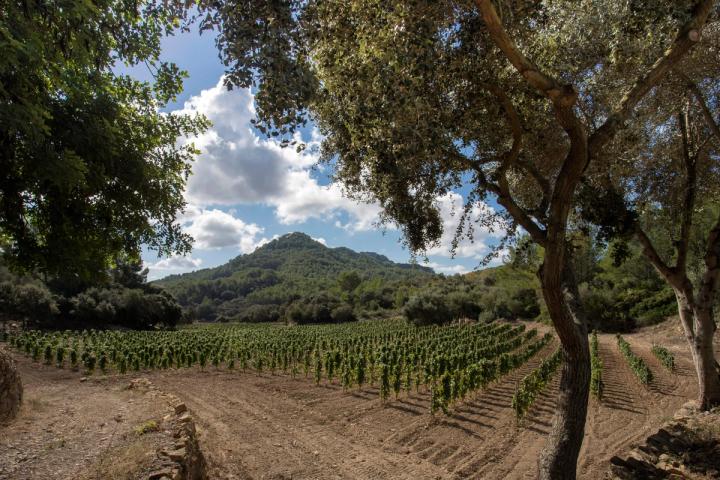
{"left": 0, "top": 347, "right": 173, "bottom": 480}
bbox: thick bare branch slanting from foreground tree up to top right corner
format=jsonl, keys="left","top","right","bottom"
{"left": 588, "top": 0, "right": 715, "bottom": 155}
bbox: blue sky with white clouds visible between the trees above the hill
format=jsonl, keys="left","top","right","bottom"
{"left": 132, "top": 26, "right": 506, "bottom": 279}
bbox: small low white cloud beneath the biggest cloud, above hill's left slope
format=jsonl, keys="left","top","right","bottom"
{"left": 185, "top": 209, "right": 267, "bottom": 253}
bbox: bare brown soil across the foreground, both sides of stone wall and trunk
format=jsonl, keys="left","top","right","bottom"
{"left": 0, "top": 321, "right": 708, "bottom": 480}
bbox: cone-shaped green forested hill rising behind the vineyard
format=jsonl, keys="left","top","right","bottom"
{"left": 155, "top": 232, "right": 436, "bottom": 321}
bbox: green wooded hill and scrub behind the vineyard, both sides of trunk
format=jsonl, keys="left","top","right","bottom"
{"left": 154, "top": 233, "right": 675, "bottom": 332}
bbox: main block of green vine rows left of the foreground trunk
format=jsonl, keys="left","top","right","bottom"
{"left": 1, "top": 320, "right": 559, "bottom": 413}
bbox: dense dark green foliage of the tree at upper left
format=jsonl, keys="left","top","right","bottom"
{"left": 0, "top": 0, "right": 207, "bottom": 283}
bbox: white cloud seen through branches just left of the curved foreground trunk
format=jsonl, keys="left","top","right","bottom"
{"left": 426, "top": 192, "right": 503, "bottom": 260}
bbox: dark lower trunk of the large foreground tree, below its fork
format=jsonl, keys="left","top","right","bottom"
{"left": 539, "top": 257, "right": 590, "bottom": 480}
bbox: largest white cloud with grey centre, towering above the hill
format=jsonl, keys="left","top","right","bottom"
{"left": 176, "top": 79, "right": 380, "bottom": 231}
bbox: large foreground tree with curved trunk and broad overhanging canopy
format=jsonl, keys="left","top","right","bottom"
{"left": 201, "top": 0, "right": 717, "bottom": 479}
